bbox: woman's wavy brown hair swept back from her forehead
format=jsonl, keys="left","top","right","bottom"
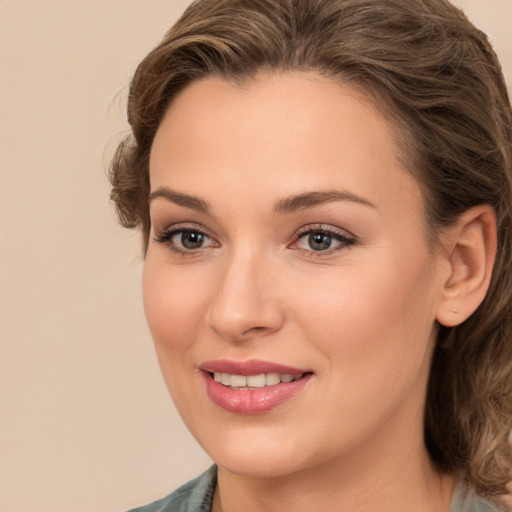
{"left": 110, "top": 0, "right": 512, "bottom": 504}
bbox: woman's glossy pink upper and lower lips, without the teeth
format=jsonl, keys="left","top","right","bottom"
{"left": 200, "top": 360, "right": 312, "bottom": 414}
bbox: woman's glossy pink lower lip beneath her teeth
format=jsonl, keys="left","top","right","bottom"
{"left": 203, "top": 372, "right": 311, "bottom": 414}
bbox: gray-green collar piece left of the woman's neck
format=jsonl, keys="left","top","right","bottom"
{"left": 128, "top": 465, "right": 217, "bottom": 512}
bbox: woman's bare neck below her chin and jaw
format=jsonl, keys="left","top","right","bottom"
{"left": 213, "top": 412, "right": 455, "bottom": 512}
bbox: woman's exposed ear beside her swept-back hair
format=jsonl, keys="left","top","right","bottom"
{"left": 436, "top": 205, "right": 497, "bottom": 327}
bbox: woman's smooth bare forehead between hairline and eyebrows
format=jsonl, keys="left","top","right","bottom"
{"left": 150, "top": 72, "right": 421, "bottom": 222}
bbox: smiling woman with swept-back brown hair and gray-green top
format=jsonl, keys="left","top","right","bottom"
{"left": 111, "top": 0, "right": 512, "bottom": 512}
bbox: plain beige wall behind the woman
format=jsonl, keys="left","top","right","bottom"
{"left": 0, "top": 0, "right": 512, "bottom": 512}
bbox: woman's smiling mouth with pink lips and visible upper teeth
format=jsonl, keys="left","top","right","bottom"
{"left": 200, "top": 361, "right": 313, "bottom": 414}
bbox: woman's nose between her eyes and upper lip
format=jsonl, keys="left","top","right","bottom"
{"left": 207, "top": 247, "right": 285, "bottom": 341}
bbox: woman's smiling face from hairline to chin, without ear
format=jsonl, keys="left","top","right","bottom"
{"left": 144, "top": 73, "right": 445, "bottom": 476}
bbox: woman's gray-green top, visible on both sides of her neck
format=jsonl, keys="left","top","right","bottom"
{"left": 128, "top": 465, "right": 501, "bottom": 512}
